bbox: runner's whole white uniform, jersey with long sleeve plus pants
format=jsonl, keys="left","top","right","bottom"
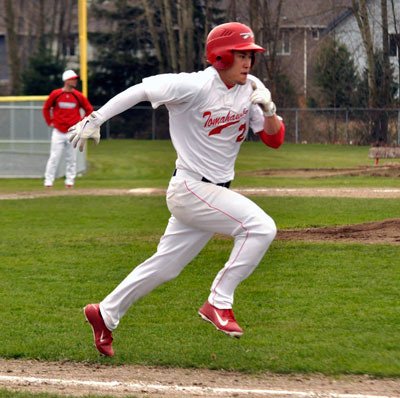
{"left": 98, "top": 67, "right": 276, "bottom": 330}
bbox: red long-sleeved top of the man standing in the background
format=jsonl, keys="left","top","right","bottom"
{"left": 43, "top": 88, "right": 93, "bottom": 133}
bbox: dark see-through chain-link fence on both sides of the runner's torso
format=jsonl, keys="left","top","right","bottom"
{"left": 102, "top": 106, "right": 400, "bottom": 145}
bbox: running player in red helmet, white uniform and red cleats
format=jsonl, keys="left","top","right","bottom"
{"left": 70, "top": 22, "right": 285, "bottom": 356}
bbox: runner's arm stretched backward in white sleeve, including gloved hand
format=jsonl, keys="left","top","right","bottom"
{"left": 68, "top": 83, "right": 148, "bottom": 152}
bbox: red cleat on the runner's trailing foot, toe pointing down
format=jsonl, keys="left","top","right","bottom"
{"left": 83, "top": 304, "right": 114, "bottom": 357}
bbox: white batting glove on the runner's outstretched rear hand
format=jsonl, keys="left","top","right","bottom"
{"left": 68, "top": 112, "right": 102, "bottom": 152}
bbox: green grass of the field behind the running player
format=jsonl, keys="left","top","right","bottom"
{"left": 0, "top": 141, "right": 400, "bottom": 384}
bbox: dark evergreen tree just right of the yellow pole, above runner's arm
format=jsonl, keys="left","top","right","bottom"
{"left": 89, "top": 0, "right": 157, "bottom": 104}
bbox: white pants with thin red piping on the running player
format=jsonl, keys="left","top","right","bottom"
{"left": 100, "top": 170, "right": 276, "bottom": 330}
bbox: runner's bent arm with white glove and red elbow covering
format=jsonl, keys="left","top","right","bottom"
{"left": 250, "top": 82, "right": 285, "bottom": 148}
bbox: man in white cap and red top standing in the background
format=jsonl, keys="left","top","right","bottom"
{"left": 43, "top": 70, "right": 93, "bottom": 188}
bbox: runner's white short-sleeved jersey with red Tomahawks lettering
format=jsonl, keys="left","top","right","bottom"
{"left": 143, "top": 67, "right": 264, "bottom": 183}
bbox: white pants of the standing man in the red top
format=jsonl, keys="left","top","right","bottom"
{"left": 44, "top": 129, "right": 77, "bottom": 186}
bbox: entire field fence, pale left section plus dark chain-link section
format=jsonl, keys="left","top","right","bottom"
{"left": 0, "top": 101, "right": 400, "bottom": 177}
